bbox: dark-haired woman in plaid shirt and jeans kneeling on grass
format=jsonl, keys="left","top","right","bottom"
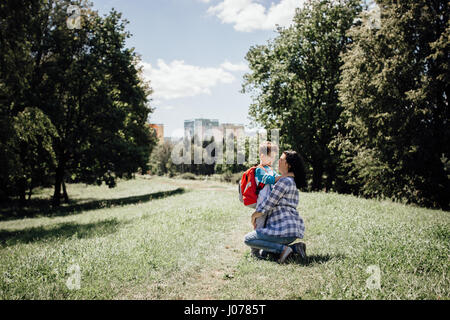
{"left": 245, "top": 151, "right": 306, "bottom": 263}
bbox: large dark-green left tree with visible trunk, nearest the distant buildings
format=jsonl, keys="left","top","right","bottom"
{"left": 47, "top": 1, "right": 155, "bottom": 204}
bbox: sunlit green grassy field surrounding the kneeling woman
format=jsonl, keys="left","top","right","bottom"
{"left": 0, "top": 177, "right": 450, "bottom": 299}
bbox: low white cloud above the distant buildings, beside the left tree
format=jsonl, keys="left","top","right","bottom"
{"left": 142, "top": 59, "right": 235, "bottom": 100}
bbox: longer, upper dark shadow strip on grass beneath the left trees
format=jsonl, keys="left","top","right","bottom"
{"left": 0, "top": 188, "right": 186, "bottom": 221}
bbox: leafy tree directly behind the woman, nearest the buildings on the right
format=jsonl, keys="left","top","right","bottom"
{"left": 243, "top": 0, "right": 361, "bottom": 190}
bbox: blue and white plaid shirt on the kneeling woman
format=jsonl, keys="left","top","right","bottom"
{"left": 256, "top": 177, "right": 305, "bottom": 238}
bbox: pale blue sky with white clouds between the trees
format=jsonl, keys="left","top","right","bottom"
{"left": 93, "top": 0, "right": 304, "bottom": 137}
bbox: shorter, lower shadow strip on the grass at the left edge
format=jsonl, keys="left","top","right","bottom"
{"left": 0, "top": 219, "right": 123, "bottom": 247}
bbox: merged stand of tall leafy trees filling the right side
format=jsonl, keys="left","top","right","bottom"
{"left": 243, "top": 0, "right": 450, "bottom": 208}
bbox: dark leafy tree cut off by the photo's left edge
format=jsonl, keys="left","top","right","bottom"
{"left": 0, "top": 0, "right": 59, "bottom": 200}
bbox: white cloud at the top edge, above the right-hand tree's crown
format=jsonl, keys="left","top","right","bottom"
{"left": 208, "top": 0, "right": 305, "bottom": 32}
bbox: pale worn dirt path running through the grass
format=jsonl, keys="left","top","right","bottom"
{"left": 119, "top": 180, "right": 251, "bottom": 300}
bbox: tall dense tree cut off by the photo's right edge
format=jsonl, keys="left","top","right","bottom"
{"left": 334, "top": 0, "right": 450, "bottom": 208}
